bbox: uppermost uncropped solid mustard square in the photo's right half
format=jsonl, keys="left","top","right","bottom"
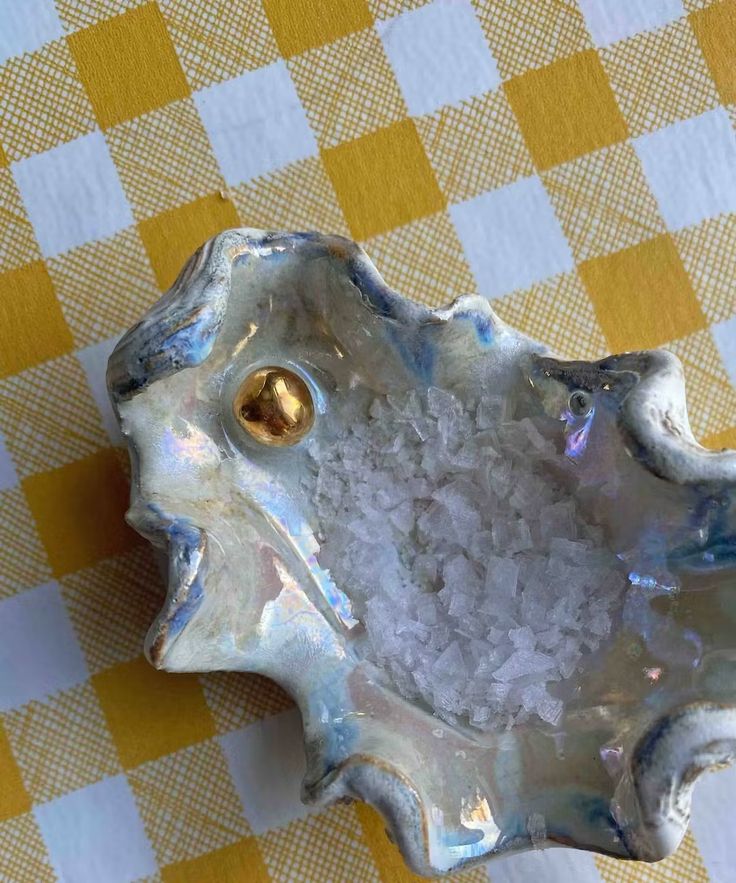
{"left": 504, "top": 49, "right": 629, "bottom": 171}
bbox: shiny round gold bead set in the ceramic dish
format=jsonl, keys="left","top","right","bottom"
{"left": 233, "top": 366, "right": 314, "bottom": 447}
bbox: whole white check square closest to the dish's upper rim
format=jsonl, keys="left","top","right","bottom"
{"left": 450, "top": 175, "right": 574, "bottom": 299}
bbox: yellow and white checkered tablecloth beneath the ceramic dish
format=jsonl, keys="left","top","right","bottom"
{"left": 0, "top": 0, "right": 736, "bottom": 883}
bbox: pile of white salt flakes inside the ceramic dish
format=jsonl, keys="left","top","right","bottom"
{"left": 305, "top": 388, "right": 626, "bottom": 729}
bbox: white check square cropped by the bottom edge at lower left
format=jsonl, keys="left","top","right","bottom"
{"left": 34, "top": 775, "right": 157, "bottom": 883}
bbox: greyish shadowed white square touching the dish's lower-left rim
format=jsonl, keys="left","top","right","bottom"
{"left": 220, "top": 709, "right": 311, "bottom": 834}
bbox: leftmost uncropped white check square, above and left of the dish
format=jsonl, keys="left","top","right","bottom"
{"left": 11, "top": 132, "right": 133, "bottom": 257}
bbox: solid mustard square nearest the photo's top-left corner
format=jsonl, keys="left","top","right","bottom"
{"left": 67, "top": 3, "right": 189, "bottom": 129}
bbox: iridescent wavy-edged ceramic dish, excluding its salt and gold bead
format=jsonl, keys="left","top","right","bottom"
{"left": 108, "top": 230, "right": 736, "bottom": 874}
